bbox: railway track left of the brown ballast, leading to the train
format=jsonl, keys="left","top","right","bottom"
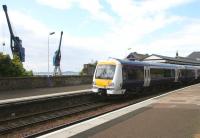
{"left": 0, "top": 101, "right": 109, "bottom": 134}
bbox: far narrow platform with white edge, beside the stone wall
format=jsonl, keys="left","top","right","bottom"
{"left": 0, "top": 84, "right": 91, "bottom": 104}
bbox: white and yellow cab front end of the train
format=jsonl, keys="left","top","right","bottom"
{"left": 92, "top": 59, "right": 124, "bottom": 95}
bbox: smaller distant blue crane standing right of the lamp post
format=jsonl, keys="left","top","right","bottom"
{"left": 53, "top": 31, "right": 63, "bottom": 75}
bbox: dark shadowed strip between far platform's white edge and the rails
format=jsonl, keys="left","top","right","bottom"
{"left": 0, "top": 92, "right": 95, "bottom": 122}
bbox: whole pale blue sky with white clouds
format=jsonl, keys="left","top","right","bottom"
{"left": 0, "top": 0, "right": 200, "bottom": 72}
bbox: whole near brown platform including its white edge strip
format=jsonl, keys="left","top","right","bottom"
{"left": 41, "top": 84, "right": 200, "bottom": 138}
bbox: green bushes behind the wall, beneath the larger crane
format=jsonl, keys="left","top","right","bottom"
{"left": 0, "top": 53, "right": 33, "bottom": 77}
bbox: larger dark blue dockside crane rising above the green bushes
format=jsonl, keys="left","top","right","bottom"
{"left": 3, "top": 5, "right": 25, "bottom": 62}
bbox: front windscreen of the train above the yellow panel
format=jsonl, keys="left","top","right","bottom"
{"left": 95, "top": 65, "right": 116, "bottom": 80}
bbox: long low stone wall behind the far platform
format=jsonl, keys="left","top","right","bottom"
{"left": 0, "top": 76, "right": 92, "bottom": 91}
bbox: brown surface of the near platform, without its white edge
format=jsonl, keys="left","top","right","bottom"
{"left": 76, "top": 84, "right": 200, "bottom": 138}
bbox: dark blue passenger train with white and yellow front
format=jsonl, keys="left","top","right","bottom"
{"left": 92, "top": 59, "right": 200, "bottom": 95}
